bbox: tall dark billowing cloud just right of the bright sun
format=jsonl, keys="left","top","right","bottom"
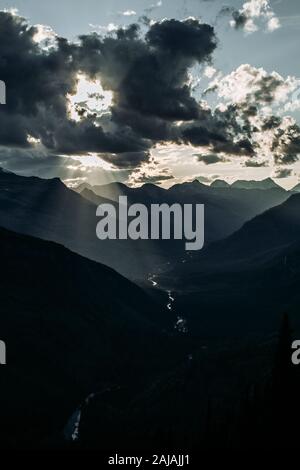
{"left": 78, "top": 20, "right": 216, "bottom": 126}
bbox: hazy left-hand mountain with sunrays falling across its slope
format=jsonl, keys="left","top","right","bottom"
{"left": 0, "top": 172, "right": 166, "bottom": 278}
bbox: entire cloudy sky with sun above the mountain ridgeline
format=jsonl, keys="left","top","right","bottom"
{"left": 0, "top": 0, "right": 300, "bottom": 188}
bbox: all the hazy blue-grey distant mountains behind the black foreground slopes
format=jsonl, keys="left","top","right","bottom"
{"left": 0, "top": 172, "right": 289, "bottom": 279}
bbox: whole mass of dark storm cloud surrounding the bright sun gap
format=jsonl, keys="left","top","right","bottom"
{"left": 0, "top": 12, "right": 290, "bottom": 173}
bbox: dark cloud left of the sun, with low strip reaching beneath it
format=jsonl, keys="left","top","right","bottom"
{"left": 0, "top": 12, "right": 150, "bottom": 167}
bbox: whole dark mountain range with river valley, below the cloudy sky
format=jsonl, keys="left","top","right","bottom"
{"left": 0, "top": 172, "right": 300, "bottom": 448}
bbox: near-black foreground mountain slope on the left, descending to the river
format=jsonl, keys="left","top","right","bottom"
{"left": 0, "top": 229, "right": 176, "bottom": 447}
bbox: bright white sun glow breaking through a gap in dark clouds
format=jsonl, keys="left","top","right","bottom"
{"left": 67, "top": 74, "right": 113, "bottom": 121}
